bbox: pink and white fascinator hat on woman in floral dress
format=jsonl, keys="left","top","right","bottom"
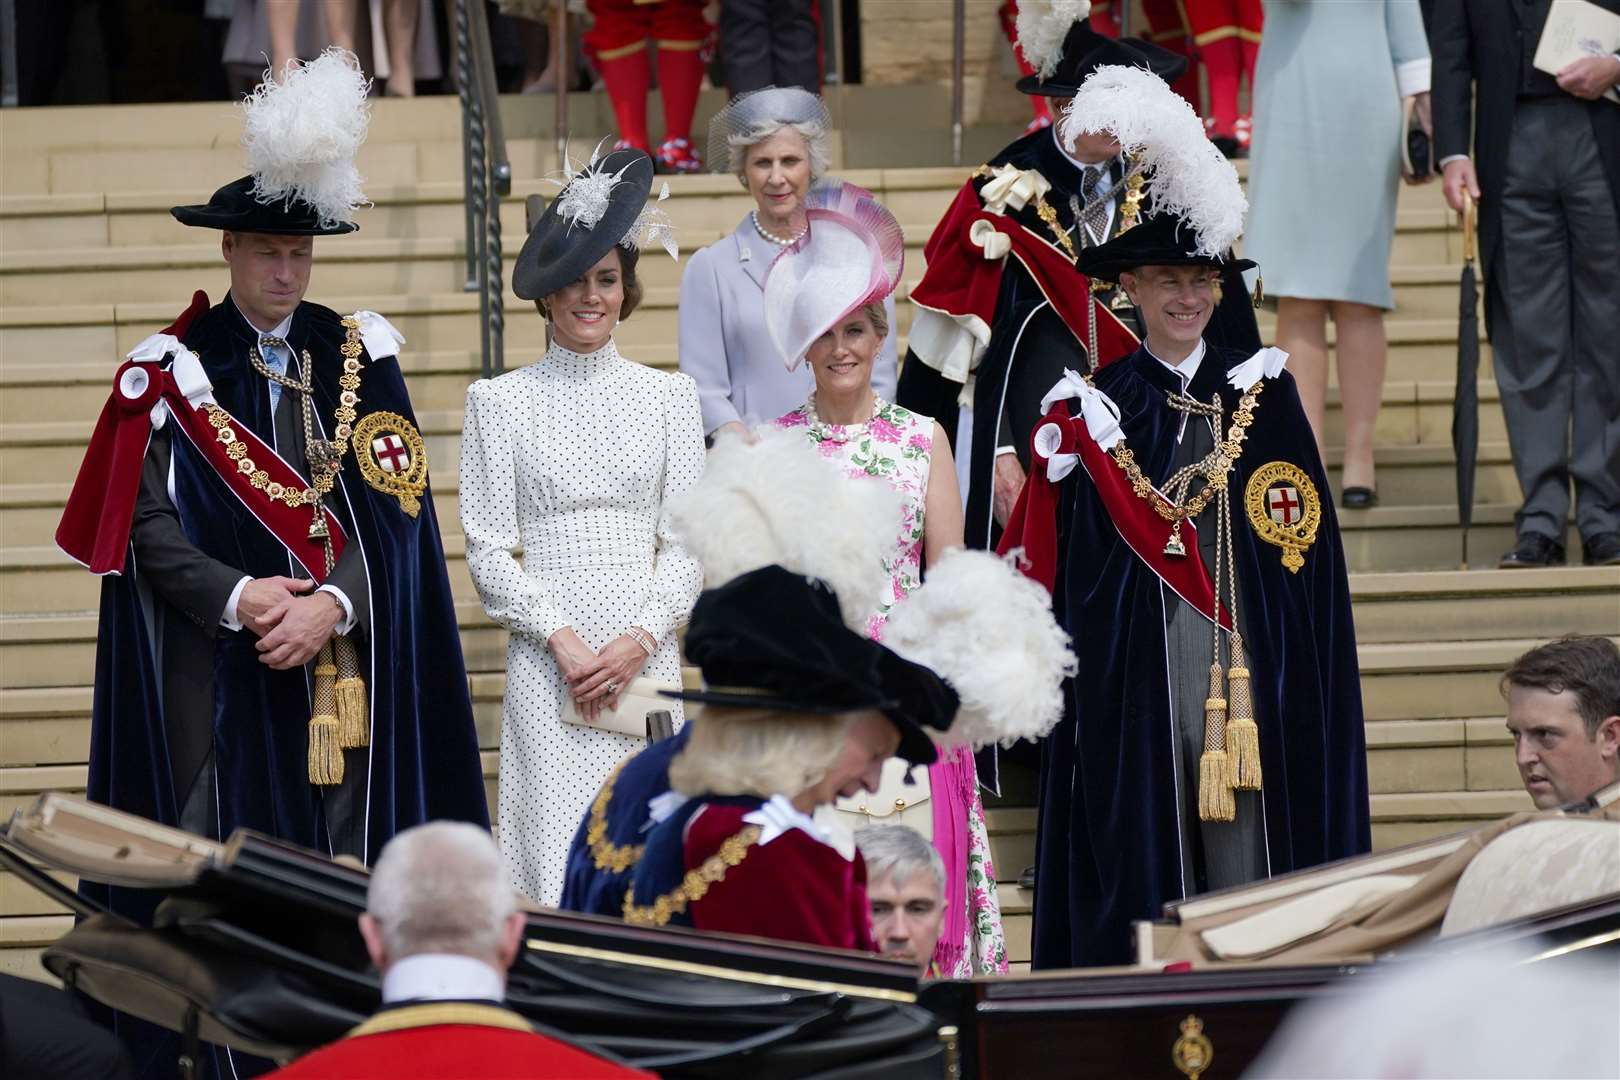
{"left": 765, "top": 181, "right": 906, "bottom": 371}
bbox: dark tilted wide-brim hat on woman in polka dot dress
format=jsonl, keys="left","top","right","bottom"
{"left": 512, "top": 149, "right": 653, "bottom": 300}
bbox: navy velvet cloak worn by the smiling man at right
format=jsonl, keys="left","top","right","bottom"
{"left": 1034, "top": 348, "right": 1371, "bottom": 968}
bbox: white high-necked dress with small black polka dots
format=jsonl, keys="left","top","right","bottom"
{"left": 460, "top": 342, "right": 703, "bottom": 907}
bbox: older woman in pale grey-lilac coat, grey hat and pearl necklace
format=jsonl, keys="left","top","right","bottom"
{"left": 680, "top": 86, "right": 896, "bottom": 436}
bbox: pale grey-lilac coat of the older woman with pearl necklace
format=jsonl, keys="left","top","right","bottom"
{"left": 679, "top": 217, "right": 899, "bottom": 434}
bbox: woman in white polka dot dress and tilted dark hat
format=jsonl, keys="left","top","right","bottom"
{"left": 460, "top": 151, "right": 703, "bottom": 905}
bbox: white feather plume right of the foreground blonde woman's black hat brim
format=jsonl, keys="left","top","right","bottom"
{"left": 883, "top": 549, "right": 1076, "bottom": 750}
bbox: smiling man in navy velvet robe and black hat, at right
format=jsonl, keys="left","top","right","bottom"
{"left": 1004, "top": 215, "right": 1371, "bottom": 968}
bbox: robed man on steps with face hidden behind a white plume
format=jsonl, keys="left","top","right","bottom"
{"left": 896, "top": 0, "right": 1187, "bottom": 547}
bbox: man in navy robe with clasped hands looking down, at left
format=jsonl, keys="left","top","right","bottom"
{"left": 57, "top": 176, "right": 489, "bottom": 1075}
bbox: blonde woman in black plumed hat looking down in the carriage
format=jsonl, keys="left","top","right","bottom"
{"left": 624, "top": 557, "right": 1072, "bottom": 952}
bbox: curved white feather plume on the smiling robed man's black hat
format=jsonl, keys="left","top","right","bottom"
{"left": 1058, "top": 65, "right": 1249, "bottom": 256}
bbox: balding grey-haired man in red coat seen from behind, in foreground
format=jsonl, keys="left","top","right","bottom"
{"left": 274, "top": 821, "right": 648, "bottom": 1080}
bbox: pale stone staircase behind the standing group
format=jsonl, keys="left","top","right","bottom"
{"left": 0, "top": 87, "right": 1620, "bottom": 975}
